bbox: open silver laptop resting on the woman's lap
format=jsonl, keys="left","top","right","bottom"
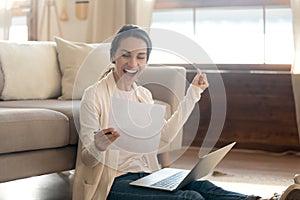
{"left": 130, "top": 142, "right": 236, "bottom": 191}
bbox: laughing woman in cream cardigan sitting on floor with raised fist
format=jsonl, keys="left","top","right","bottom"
{"left": 73, "top": 24, "right": 231, "bottom": 200}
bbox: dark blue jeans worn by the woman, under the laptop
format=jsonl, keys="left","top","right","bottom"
{"left": 107, "top": 173, "right": 257, "bottom": 200}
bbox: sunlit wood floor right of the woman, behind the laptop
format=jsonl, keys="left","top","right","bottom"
{"left": 172, "top": 148, "right": 300, "bottom": 197}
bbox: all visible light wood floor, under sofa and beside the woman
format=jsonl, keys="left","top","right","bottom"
{"left": 0, "top": 148, "right": 300, "bottom": 200}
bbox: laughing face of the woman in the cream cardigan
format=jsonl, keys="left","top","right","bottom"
{"left": 113, "top": 37, "right": 147, "bottom": 90}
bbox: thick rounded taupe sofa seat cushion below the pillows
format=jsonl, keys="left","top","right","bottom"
{"left": 0, "top": 108, "right": 69, "bottom": 154}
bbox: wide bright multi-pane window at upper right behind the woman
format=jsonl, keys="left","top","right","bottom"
{"left": 150, "top": 1, "right": 294, "bottom": 64}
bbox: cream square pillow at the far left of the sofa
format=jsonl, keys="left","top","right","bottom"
{"left": 0, "top": 41, "right": 61, "bottom": 100}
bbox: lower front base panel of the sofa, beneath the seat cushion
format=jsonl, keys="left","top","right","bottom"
{"left": 0, "top": 146, "right": 77, "bottom": 183}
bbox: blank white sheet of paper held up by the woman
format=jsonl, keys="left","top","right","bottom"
{"left": 108, "top": 97, "right": 165, "bottom": 153}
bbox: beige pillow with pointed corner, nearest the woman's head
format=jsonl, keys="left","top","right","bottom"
{"left": 55, "top": 37, "right": 110, "bottom": 100}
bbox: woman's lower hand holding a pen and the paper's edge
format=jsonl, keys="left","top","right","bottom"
{"left": 94, "top": 128, "right": 120, "bottom": 151}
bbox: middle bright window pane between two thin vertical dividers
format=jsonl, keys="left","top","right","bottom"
{"left": 195, "top": 8, "right": 264, "bottom": 63}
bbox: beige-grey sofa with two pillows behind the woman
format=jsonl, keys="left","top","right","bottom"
{"left": 0, "top": 39, "right": 186, "bottom": 182}
